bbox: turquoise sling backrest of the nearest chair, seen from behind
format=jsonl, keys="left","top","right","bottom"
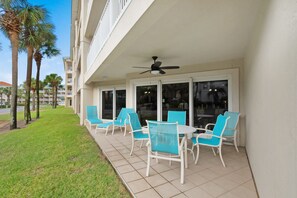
{"left": 147, "top": 121, "right": 180, "bottom": 155}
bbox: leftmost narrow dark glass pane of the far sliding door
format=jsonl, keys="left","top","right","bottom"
{"left": 101, "top": 91, "right": 113, "bottom": 119}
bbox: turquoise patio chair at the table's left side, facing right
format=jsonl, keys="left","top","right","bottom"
{"left": 128, "top": 113, "right": 149, "bottom": 155}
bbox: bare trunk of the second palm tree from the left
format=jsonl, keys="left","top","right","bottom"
{"left": 24, "top": 46, "right": 33, "bottom": 124}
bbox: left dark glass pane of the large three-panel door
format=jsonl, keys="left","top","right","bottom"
{"left": 136, "top": 85, "right": 157, "bottom": 125}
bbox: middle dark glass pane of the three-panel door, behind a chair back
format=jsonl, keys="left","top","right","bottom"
{"left": 162, "top": 83, "right": 189, "bottom": 124}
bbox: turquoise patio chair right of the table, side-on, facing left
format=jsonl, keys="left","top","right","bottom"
{"left": 192, "top": 115, "right": 229, "bottom": 167}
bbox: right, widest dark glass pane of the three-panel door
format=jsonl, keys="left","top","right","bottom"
{"left": 193, "top": 80, "right": 228, "bottom": 128}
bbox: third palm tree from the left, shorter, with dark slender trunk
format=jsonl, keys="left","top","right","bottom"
{"left": 34, "top": 23, "right": 60, "bottom": 119}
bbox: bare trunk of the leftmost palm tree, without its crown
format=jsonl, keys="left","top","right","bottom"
{"left": 9, "top": 32, "right": 19, "bottom": 129}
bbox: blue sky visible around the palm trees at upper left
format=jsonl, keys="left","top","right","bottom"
{"left": 0, "top": 0, "right": 71, "bottom": 84}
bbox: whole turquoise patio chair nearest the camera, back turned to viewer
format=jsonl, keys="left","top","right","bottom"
{"left": 146, "top": 121, "right": 185, "bottom": 184}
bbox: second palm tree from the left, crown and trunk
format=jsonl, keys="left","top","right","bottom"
{"left": 20, "top": 5, "right": 47, "bottom": 124}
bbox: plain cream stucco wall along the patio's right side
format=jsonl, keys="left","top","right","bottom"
{"left": 244, "top": 0, "right": 297, "bottom": 198}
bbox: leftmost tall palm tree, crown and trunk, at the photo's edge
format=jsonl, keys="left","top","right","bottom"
{"left": 0, "top": 0, "right": 25, "bottom": 129}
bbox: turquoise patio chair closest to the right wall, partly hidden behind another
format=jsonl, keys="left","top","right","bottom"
{"left": 223, "top": 111, "right": 240, "bottom": 152}
